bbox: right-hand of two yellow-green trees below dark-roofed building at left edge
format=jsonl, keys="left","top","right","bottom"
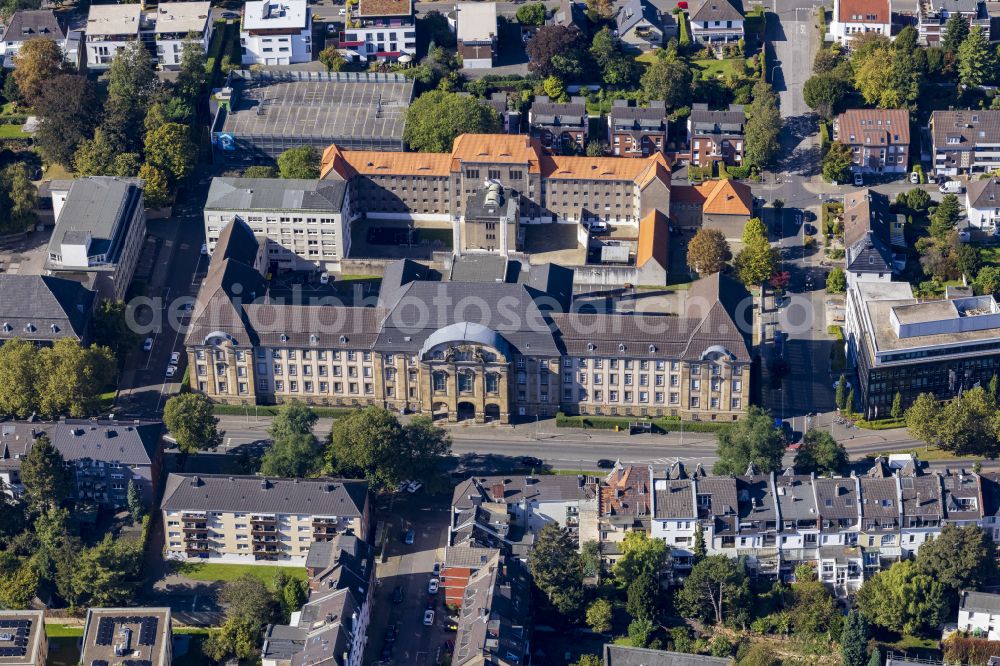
{"left": 36, "top": 338, "right": 116, "bottom": 418}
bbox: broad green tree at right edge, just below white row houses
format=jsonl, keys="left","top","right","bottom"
{"left": 917, "top": 524, "right": 997, "bottom": 588}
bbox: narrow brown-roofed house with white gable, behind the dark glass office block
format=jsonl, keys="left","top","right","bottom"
{"left": 844, "top": 188, "right": 906, "bottom": 285}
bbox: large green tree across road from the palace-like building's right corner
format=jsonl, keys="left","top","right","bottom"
{"left": 714, "top": 405, "right": 787, "bottom": 474}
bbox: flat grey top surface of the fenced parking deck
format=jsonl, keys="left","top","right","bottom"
{"left": 213, "top": 71, "right": 413, "bottom": 143}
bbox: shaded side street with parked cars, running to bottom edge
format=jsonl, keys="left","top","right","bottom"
{"left": 364, "top": 492, "right": 455, "bottom": 666}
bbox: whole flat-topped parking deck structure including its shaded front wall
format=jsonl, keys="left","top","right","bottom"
{"left": 211, "top": 70, "right": 413, "bottom": 164}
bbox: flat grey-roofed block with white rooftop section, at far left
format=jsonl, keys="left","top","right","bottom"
{"left": 45, "top": 176, "right": 146, "bottom": 300}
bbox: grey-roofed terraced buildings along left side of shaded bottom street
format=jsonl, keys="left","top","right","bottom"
{"left": 261, "top": 534, "right": 375, "bottom": 666}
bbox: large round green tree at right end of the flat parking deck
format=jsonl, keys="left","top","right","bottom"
{"left": 403, "top": 90, "right": 500, "bottom": 153}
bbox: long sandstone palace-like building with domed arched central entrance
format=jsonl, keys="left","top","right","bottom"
{"left": 185, "top": 220, "right": 752, "bottom": 423}
